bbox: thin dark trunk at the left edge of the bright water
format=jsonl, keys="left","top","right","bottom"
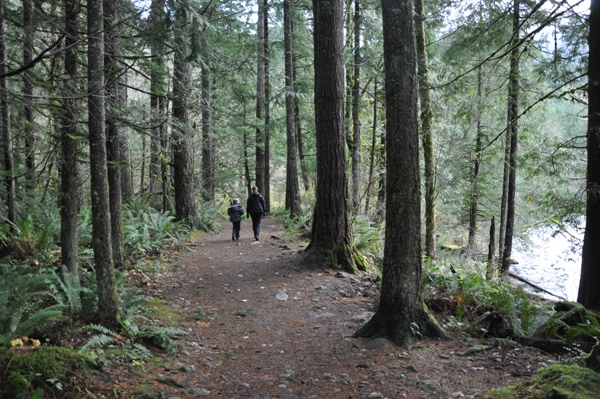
{"left": 501, "top": 0, "right": 521, "bottom": 273}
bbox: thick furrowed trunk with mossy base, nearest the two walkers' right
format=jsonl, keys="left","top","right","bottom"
{"left": 305, "top": 0, "right": 366, "bottom": 272}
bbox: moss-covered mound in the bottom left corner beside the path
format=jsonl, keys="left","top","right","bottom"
{"left": 0, "top": 346, "right": 97, "bottom": 399}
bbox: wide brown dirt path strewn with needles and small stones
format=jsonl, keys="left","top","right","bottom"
{"left": 95, "top": 218, "right": 558, "bottom": 399}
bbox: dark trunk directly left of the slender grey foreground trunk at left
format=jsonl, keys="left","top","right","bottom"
{"left": 60, "top": 0, "right": 81, "bottom": 276}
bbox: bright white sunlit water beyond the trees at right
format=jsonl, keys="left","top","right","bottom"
{"left": 511, "top": 224, "right": 584, "bottom": 301}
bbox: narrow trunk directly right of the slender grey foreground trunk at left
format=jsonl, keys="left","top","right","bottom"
{"left": 104, "top": 0, "right": 125, "bottom": 269}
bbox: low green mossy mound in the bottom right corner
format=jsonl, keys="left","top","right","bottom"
{"left": 486, "top": 365, "right": 600, "bottom": 399}
